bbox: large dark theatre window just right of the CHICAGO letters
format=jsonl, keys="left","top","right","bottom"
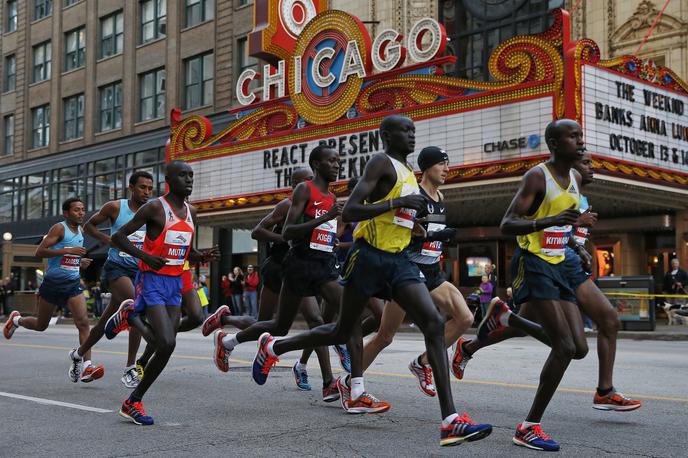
{"left": 439, "top": 0, "right": 564, "bottom": 81}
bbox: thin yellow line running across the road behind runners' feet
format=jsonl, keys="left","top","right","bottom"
{"left": 2, "top": 343, "right": 688, "bottom": 404}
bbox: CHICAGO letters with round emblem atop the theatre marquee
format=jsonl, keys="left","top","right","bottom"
{"left": 236, "top": 10, "right": 447, "bottom": 125}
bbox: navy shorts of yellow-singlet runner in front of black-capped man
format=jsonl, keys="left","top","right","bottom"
{"left": 341, "top": 239, "right": 423, "bottom": 300}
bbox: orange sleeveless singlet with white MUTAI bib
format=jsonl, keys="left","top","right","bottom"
{"left": 139, "top": 196, "right": 194, "bottom": 277}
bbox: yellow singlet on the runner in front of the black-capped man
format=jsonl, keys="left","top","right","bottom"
{"left": 354, "top": 153, "right": 419, "bottom": 253}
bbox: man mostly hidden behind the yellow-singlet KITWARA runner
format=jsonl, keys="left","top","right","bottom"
{"left": 454, "top": 153, "right": 642, "bottom": 411}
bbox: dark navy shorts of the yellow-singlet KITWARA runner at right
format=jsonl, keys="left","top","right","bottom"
{"left": 511, "top": 248, "right": 576, "bottom": 305}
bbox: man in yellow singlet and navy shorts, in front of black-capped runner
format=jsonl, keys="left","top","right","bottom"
{"left": 253, "top": 115, "right": 492, "bottom": 446}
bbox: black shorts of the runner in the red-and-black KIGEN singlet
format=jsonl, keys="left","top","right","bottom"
{"left": 282, "top": 250, "right": 339, "bottom": 297}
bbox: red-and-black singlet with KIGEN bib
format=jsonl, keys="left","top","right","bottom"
{"left": 292, "top": 181, "right": 337, "bottom": 253}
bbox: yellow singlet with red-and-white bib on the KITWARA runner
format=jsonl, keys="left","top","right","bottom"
{"left": 517, "top": 163, "right": 580, "bottom": 264}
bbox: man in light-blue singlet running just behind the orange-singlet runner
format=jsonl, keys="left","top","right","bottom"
{"left": 69, "top": 171, "right": 153, "bottom": 388}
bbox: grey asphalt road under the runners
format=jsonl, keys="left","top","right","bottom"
{"left": 0, "top": 326, "right": 688, "bottom": 457}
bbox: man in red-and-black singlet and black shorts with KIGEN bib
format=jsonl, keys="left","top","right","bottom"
{"left": 214, "top": 146, "right": 350, "bottom": 402}
